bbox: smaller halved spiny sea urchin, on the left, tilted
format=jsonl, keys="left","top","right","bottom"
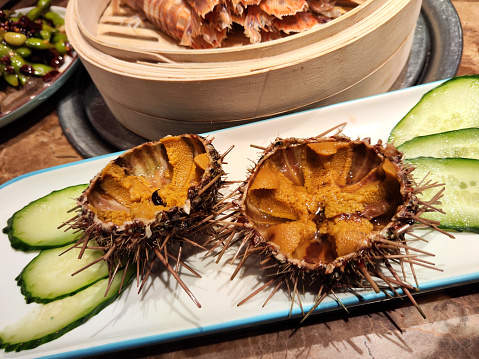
{"left": 69, "top": 134, "right": 224, "bottom": 306}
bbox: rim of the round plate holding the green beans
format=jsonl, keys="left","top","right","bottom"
{"left": 0, "top": 6, "right": 80, "bottom": 128}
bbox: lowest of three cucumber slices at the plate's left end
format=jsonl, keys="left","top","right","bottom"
{"left": 0, "top": 266, "right": 136, "bottom": 352}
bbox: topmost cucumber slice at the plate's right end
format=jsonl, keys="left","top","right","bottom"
{"left": 388, "top": 75, "right": 479, "bottom": 147}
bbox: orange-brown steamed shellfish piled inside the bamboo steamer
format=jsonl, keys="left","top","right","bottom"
{"left": 113, "top": 0, "right": 363, "bottom": 48}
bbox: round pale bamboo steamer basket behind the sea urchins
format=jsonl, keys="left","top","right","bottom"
{"left": 66, "top": 0, "right": 421, "bottom": 139}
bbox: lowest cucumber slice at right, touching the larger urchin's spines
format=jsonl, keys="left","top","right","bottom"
{"left": 406, "top": 157, "right": 479, "bottom": 233}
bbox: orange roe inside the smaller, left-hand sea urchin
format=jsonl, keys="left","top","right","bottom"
{"left": 93, "top": 136, "right": 209, "bottom": 225}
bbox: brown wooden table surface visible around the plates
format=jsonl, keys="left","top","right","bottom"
{"left": 0, "top": 0, "right": 479, "bottom": 359}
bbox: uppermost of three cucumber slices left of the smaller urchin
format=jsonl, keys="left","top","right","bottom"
{"left": 3, "top": 184, "right": 87, "bottom": 251}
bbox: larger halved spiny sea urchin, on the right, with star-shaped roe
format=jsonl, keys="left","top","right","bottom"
{"left": 217, "top": 126, "right": 454, "bottom": 316}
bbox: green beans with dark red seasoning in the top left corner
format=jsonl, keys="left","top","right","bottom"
{"left": 0, "top": 0, "right": 73, "bottom": 112}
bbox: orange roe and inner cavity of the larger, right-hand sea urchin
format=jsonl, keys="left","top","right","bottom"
{"left": 245, "top": 138, "right": 402, "bottom": 267}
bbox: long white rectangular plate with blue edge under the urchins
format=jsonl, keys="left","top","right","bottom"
{"left": 0, "top": 83, "right": 479, "bottom": 358}
